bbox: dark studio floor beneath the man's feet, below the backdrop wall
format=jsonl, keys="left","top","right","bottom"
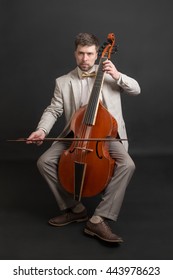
{"left": 0, "top": 156, "right": 173, "bottom": 260}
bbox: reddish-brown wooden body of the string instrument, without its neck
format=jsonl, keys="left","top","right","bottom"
{"left": 58, "top": 102, "right": 117, "bottom": 199}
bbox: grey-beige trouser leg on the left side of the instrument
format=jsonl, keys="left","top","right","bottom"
{"left": 37, "top": 141, "right": 78, "bottom": 210}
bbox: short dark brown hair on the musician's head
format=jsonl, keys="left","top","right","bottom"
{"left": 75, "top": 33, "right": 99, "bottom": 51}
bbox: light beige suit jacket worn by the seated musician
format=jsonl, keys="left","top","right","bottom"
{"left": 37, "top": 68, "right": 140, "bottom": 150}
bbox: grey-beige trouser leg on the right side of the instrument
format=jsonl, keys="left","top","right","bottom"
{"left": 94, "top": 142, "right": 135, "bottom": 221}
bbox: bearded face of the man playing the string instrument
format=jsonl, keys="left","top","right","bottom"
{"left": 75, "top": 45, "right": 97, "bottom": 71}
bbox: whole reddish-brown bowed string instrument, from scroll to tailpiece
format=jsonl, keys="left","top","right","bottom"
{"left": 58, "top": 33, "right": 118, "bottom": 201}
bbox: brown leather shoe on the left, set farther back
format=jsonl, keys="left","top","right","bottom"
{"left": 48, "top": 209, "right": 88, "bottom": 227}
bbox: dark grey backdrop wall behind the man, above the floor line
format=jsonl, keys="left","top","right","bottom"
{"left": 0, "top": 0, "right": 173, "bottom": 159}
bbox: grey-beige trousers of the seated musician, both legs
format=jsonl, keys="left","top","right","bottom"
{"left": 37, "top": 141, "right": 135, "bottom": 221}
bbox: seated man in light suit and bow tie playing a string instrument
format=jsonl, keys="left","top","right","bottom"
{"left": 27, "top": 33, "right": 140, "bottom": 243}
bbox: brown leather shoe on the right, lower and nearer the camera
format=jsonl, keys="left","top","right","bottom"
{"left": 84, "top": 221, "right": 123, "bottom": 243}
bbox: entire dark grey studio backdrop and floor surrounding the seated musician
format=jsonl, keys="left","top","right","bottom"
{"left": 0, "top": 0, "right": 173, "bottom": 260}
